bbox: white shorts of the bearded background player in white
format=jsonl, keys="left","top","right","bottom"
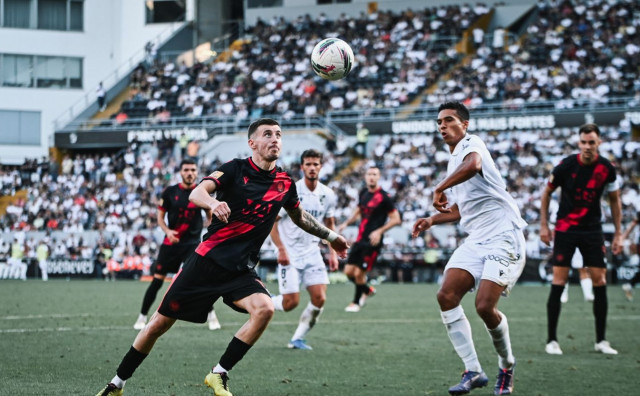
{"left": 278, "top": 250, "right": 329, "bottom": 294}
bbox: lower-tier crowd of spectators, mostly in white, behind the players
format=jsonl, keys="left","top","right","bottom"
{"left": 0, "top": 120, "right": 640, "bottom": 270}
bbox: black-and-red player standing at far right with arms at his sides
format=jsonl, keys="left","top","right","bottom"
{"left": 540, "top": 124, "right": 623, "bottom": 355}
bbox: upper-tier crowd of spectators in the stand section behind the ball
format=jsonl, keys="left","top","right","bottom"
{"left": 106, "top": 3, "right": 489, "bottom": 124}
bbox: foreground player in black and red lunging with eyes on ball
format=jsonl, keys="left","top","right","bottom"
{"left": 98, "top": 118, "right": 349, "bottom": 396}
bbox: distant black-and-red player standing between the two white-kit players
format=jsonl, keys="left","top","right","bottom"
{"left": 338, "top": 166, "right": 401, "bottom": 312}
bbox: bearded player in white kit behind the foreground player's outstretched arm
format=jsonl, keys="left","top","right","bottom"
{"left": 271, "top": 149, "right": 338, "bottom": 350}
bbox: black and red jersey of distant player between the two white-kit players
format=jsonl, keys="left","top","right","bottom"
{"left": 357, "top": 187, "right": 396, "bottom": 244}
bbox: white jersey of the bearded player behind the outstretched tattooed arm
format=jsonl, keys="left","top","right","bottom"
{"left": 278, "top": 179, "right": 337, "bottom": 263}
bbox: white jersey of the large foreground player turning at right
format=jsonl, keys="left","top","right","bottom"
{"left": 446, "top": 134, "right": 527, "bottom": 241}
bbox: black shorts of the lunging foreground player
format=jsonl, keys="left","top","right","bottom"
{"left": 158, "top": 253, "right": 270, "bottom": 323}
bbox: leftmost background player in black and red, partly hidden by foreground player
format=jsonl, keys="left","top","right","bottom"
{"left": 133, "top": 158, "right": 220, "bottom": 330}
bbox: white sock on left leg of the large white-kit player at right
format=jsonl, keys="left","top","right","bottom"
{"left": 440, "top": 305, "right": 482, "bottom": 372}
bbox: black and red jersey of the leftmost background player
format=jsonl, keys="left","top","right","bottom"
{"left": 158, "top": 183, "right": 202, "bottom": 245}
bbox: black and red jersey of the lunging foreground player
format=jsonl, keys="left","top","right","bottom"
{"left": 196, "top": 158, "right": 300, "bottom": 271}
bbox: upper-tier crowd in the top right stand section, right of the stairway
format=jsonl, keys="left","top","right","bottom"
{"left": 425, "top": 0, "right": 640, "bottom": 109}
